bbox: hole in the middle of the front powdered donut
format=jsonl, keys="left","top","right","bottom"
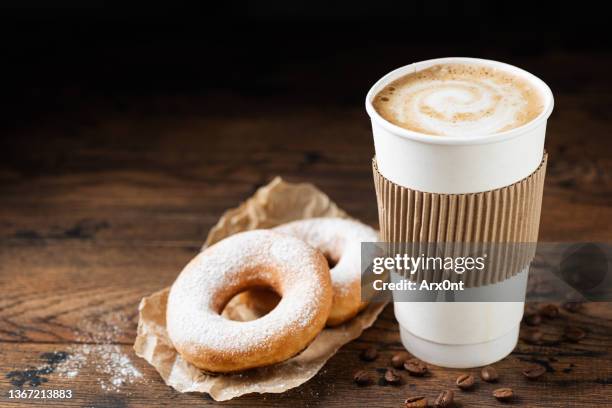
{"left": 221, "top": 287, "right": 281, "bottom": 322}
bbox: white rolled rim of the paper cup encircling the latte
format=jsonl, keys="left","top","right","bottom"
{"left": 365, "top": 57, "right": 554, "bottom": 145}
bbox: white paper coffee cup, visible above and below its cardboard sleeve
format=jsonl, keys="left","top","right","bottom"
{"left": 366, "top": 58, "right": 554, "bottom": 368}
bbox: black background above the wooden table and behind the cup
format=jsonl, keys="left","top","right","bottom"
{"left": 0, "top": 0, "right": 612, "bottom": 129}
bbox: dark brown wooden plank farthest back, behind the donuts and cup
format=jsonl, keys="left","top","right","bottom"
{"left": 0, "top": 99, "right": 612, "bottom": 245}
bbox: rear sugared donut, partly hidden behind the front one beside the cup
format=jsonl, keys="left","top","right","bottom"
{"left": 274, "top": 218, "right": 378, "bottom": 326}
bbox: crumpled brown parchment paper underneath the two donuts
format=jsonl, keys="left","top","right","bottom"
{"left": 134, "top": 177, "right": 385, "bottom": 401}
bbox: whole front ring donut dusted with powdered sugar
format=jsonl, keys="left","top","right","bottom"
{"left": 166, "top": 230, "right": 332, "bottom": 372}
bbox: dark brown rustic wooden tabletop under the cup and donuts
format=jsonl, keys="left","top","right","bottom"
{"left": 0, "top": 50, "right": 612, "bottom": 407}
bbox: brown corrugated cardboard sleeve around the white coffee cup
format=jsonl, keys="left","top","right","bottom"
{"left": 372, "top": 153, "right": 548, "bottom": 287}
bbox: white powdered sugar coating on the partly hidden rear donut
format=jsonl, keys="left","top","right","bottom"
{"left": 274, "top": 218, "right": 378, "bottom": 292}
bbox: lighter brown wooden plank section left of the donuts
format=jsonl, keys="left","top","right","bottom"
{"left": 0, "top": 244, "right": 191, "bottom": 344}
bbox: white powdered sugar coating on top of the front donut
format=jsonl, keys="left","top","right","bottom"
{"left": 167, "top": 230, "right": 325, "bottom": 352}
